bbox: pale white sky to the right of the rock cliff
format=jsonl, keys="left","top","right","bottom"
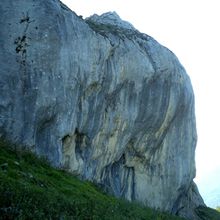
{"left": 62, "top": 0, "right": 220, "bottom": 206}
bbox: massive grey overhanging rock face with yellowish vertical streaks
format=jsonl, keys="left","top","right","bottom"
{"left": 0, "top": 0, "right": 203, "bottom": 219}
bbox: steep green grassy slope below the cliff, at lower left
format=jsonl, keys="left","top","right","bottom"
{"left": 0, "top": 141, "right": 189, "bottom": 220}
